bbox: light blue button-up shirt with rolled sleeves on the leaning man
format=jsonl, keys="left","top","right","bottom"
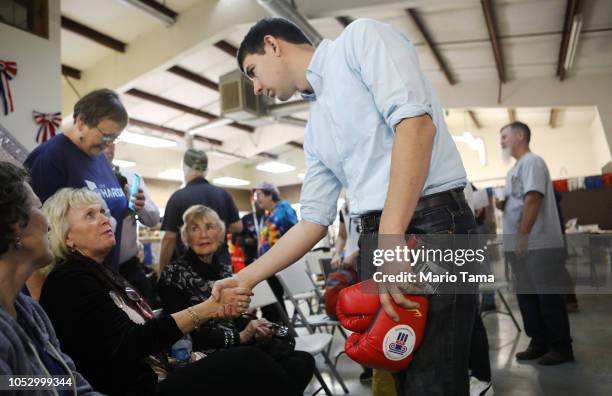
{"left": 300, "top": 19, "right": 466, "bottom": 226}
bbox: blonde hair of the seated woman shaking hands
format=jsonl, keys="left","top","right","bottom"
{"left": 43, "top": 188, "right": 106, "bottom": 273}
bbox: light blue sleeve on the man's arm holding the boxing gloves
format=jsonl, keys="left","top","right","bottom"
{"left": 346, "top": 19, "right": 433, "bottom": 130}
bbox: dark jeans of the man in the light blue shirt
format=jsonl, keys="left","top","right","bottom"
{"left": 364, "top": 193, "right": 478, "bottom": 396}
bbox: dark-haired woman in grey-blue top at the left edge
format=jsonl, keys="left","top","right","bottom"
{"left": 0, "top": 162, "right": 99, "bottom": 395}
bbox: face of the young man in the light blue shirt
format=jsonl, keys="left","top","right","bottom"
{"left": 242, "top": 36, "right": 296, "bottom": 101}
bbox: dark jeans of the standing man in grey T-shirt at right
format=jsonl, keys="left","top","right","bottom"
{"left": 506, "top": 249, "right": 572, "bottom": 353}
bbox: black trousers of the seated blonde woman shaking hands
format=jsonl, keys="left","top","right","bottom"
{"left": 156, "top": 347, "right": 314, "bottom": 396}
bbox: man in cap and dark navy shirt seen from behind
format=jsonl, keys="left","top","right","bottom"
{"left": 159, "top": 149, "right": 242, "bottom": 274}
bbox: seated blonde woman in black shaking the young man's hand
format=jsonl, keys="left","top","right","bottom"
{"left": 40, "top": 188, "right": 290, "bottom": 395}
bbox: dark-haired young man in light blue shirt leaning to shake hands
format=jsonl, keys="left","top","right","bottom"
{"left": 216, "top": 18, "right": 476, "bottom": 395}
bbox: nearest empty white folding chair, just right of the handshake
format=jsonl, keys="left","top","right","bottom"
{"left": 249, "top": 282, "right": 348, "bottom": 396}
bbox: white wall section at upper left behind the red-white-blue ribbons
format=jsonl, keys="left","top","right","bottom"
{"left": 0, "top": 1, "right": 62, "bottom": 150}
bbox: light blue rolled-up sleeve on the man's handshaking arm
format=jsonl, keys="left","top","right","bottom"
{"left": 300, "top": 145, "right": 342, "bottom": 227}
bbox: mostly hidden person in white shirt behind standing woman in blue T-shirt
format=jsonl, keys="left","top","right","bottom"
{"left": 104, "top": 142, "right": 159, "bottom": 306}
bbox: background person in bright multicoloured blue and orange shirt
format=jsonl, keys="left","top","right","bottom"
{"left": 255, "top": 182, "right": 297, "bottom": 323}
